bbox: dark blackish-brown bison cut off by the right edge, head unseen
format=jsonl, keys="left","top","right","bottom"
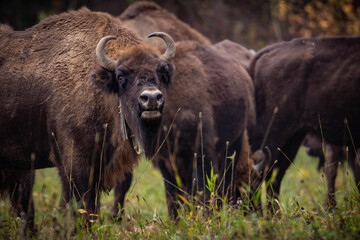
{"left": 250, "top": 37, "right": 360, "bottom": 209}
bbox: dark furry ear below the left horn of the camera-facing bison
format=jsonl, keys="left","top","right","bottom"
{"left": 91, "top": 68, "right": 119, "bottom": 93}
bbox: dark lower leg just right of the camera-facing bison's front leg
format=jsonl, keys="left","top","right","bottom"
{"left": 110, "top": 172, "right": 133, "bottom": 221}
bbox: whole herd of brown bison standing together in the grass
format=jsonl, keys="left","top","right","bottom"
{"left": 0, "top": 2, "right": 360, "bottom": 234}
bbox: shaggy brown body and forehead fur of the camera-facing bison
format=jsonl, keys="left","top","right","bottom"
{"left": 0, "top": 8, "right": 174, "bottom": 225}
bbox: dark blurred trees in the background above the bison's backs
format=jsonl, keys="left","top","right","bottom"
{"left": 0, "top": 0, "right": 360, "bottom": 50}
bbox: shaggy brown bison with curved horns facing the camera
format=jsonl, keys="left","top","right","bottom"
{"left": 0, "top": 8, "right": 175, "bottom": 229}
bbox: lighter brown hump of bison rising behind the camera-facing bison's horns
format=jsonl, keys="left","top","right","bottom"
{"left": 118, "top": 1, "right": 211, "bottom": 49}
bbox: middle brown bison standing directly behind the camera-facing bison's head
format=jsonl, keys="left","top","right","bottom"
{"left": 112, "top": 41, "right": 261, "bottom": 218}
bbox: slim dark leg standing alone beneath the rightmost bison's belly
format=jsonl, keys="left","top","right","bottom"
{"left": 324, "top": 143, "right": 341, "bottom": 208}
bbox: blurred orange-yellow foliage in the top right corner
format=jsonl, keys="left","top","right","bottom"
{"left": 279, "top": 0, "right": 360, "bottom": 37}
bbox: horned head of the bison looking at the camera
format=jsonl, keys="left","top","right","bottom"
{"left": 93, "top": 32, "right": 175, "bottom": 157}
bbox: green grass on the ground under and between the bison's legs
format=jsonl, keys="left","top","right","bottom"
{"left": 0, "top": 149, "right": 360, "bottom": 239}
